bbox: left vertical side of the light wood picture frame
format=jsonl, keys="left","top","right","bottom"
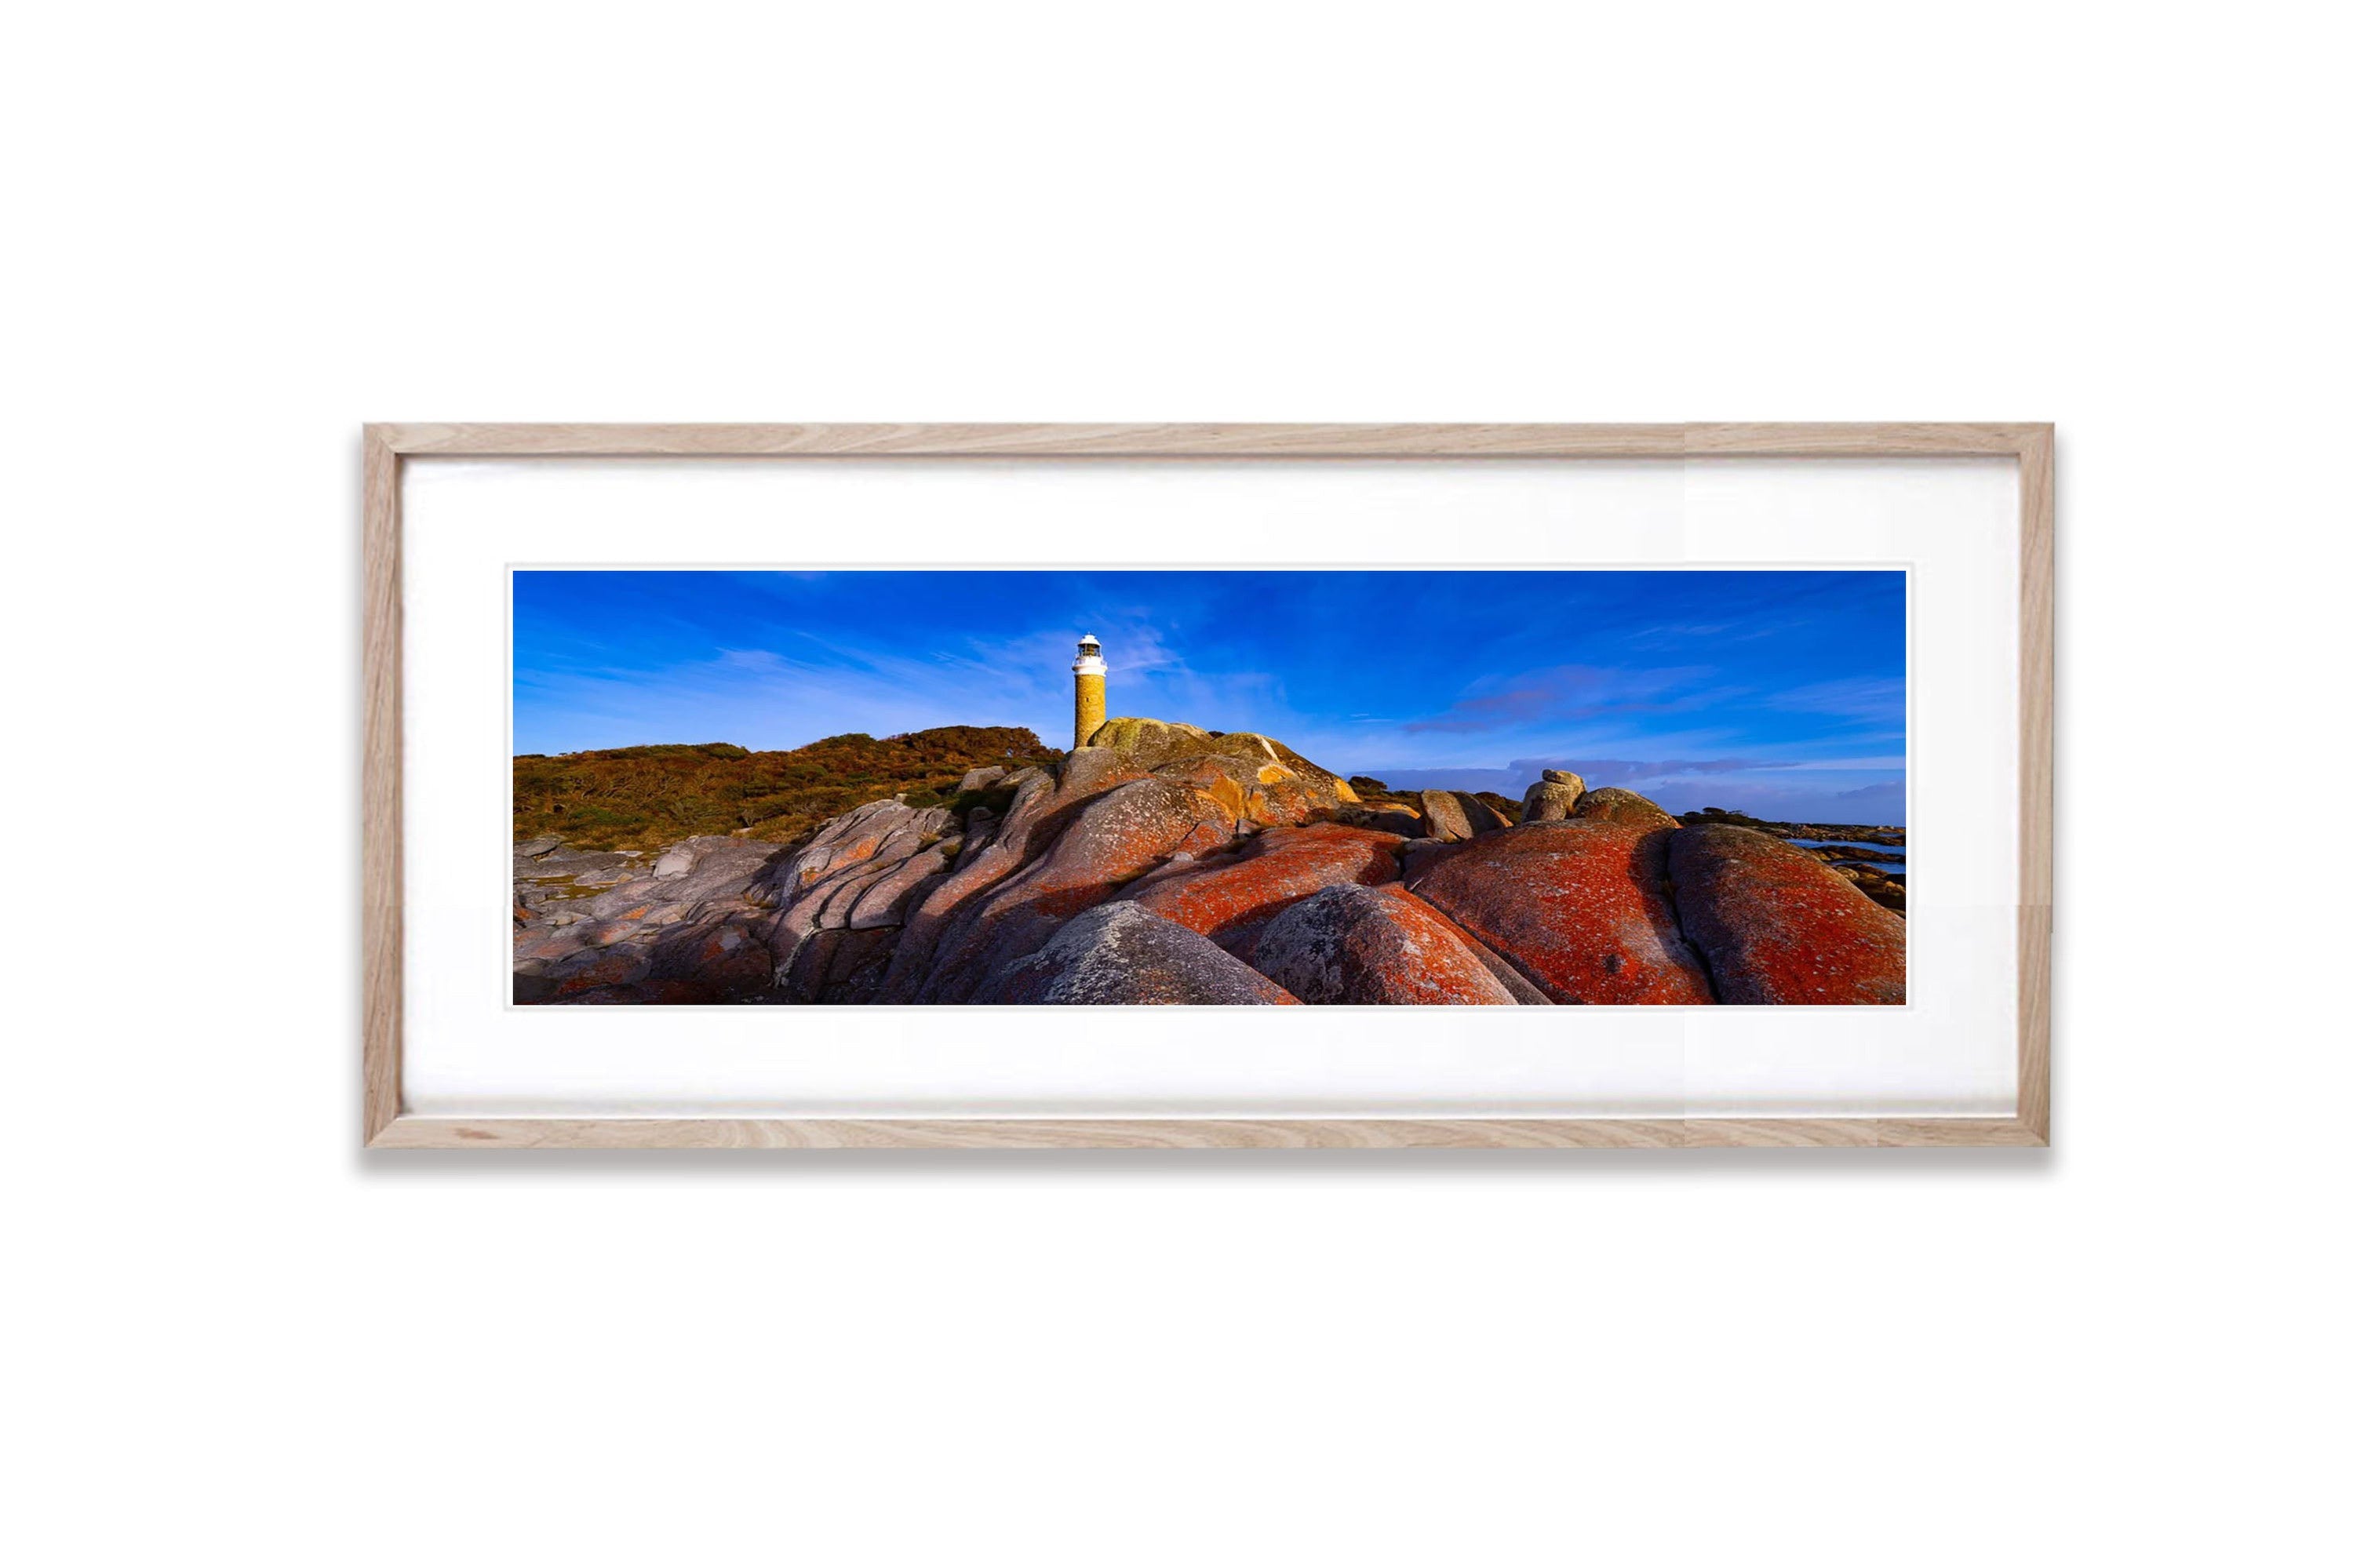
{"left": 360, "top": 425, "right": 402, "bottom": 1138}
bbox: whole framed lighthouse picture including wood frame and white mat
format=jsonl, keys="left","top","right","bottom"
{"left": 362, "top": 423, "right": 2052, "bottom": 1148}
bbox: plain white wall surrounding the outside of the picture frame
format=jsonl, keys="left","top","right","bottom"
{"left": 0, "top": 2, "right": 2348, "bottom": 1563}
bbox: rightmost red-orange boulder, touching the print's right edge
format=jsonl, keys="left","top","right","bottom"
{"left": 1668, "top": 825, "right": 1903, "bottom": 1006}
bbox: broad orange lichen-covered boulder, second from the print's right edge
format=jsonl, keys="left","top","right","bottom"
{"left": 1407, "top": 820, "right": 1715, "bottom": 1006}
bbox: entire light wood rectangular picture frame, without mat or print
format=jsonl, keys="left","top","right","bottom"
{"left": 360, "top": 423, "right": 2054, "bottom": 1150}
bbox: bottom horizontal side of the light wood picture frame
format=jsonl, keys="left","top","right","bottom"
{"left": 370, "top": 1117, "right": 2042, "bottom": 1150}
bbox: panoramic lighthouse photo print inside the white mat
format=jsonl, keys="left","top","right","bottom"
{"left": 513, "top": 569, "right": 1906, "bottom": 1006}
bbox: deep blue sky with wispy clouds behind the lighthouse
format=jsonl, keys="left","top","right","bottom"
{"left": 515, "top": 571, "right": 1903, "bottom": 823}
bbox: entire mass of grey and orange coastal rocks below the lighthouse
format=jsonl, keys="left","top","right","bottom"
{"left": 513, "top": 719, "right": 1903, "bottom": 1006}
